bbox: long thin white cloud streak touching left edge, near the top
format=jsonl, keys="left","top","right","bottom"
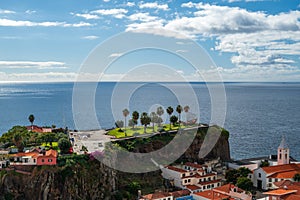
{"left": 0, "top": 19, "right": 92, "bottom": 27}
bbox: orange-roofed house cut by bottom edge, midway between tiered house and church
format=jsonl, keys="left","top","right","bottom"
{"left": 192, "top": 184, "right": 252, "bottom": 200}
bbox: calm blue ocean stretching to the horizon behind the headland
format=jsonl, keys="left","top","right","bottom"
{"left": 0, "top": 82, "right": 300, "bottom": 160}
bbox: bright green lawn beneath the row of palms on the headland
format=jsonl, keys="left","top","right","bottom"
{"left": 108, "top": 124, "right": 185, "bottom": 138}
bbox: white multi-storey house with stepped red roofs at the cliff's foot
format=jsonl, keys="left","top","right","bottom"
{"left": 162, "top": 163, "right": 221, "bottom": 193}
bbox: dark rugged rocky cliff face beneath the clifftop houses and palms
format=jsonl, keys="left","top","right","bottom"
{"left": 0, "top": 126, "right": 230, "bottom": 200}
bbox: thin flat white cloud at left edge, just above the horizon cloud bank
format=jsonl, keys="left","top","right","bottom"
{"left": 0, "top": 61, "right": 67, "bottom": 69}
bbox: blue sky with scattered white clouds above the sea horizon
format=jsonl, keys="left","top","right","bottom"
{"left": 0, "top": 0, "right": 300, "bottom": 82}
